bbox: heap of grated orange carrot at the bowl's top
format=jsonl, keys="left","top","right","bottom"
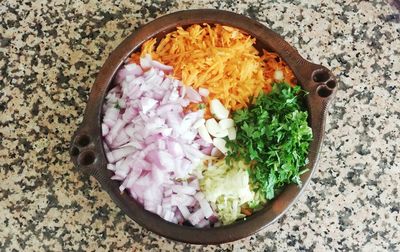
{"left": 131, "top": 24, "right": 296, "bottom": 113}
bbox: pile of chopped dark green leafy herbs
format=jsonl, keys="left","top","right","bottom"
{"left": 227, "top": 83, "right": 312, "bottom": 205}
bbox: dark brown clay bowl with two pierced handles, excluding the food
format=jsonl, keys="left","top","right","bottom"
{"left": 71, "top": 10, "right": 337, "bottom": 244}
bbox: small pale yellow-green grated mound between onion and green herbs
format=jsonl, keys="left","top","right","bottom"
{"left": 200, "top": 160, "right": 254, "bottom": 225}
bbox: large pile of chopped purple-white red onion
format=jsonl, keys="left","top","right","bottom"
{"left": 102, "top": 55, "right": 216, "bottom": 224}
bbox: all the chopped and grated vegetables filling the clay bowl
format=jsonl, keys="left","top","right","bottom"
{"left": 102, "top": 24, "right": 312, "bottom": 228}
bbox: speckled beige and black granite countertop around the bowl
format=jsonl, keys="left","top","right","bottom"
{"left": 0, "top": 0, "right": 400, "bottom": 251}
